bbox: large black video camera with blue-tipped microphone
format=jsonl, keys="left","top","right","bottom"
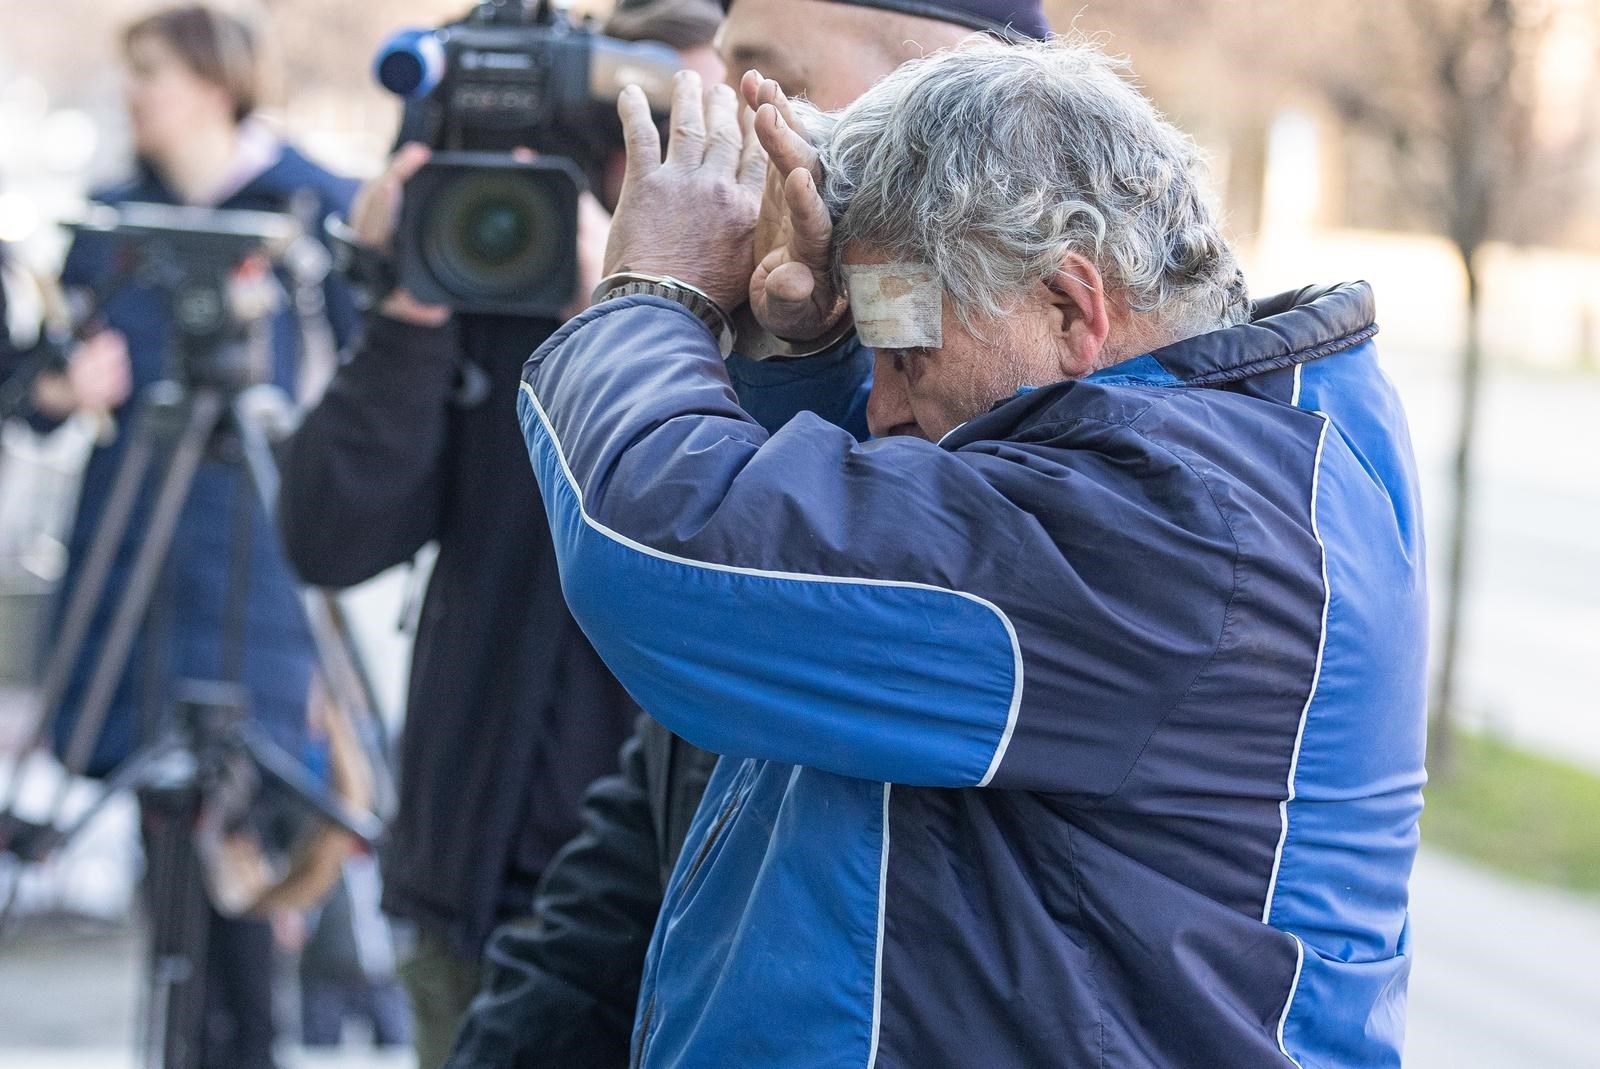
{"left": 374, "top": 0, "right": 678, "bottom": 317}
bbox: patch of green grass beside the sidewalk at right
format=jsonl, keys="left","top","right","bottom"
{"left": 1422, "top": 731, "right": 1600, "bottom": 898}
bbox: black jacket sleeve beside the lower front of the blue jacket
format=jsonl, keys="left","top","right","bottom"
{"left": 445, "top": 717, "right": 717, "bottom": 1069}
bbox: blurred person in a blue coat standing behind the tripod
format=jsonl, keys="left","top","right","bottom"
{"left": 7, "top": 5, "right": 355, "bottom": 1069}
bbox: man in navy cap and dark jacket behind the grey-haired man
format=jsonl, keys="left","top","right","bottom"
{"left": 448, "top": 0, "right": 1048, "bottom": 1069}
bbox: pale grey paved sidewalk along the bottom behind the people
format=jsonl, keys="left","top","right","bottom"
{"left": 0, "top": 851, "right": 1600, "bottom": 1069}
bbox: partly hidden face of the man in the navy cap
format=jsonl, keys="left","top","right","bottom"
{"left": 717, "top": 0, "right": 971, "bottom": 112}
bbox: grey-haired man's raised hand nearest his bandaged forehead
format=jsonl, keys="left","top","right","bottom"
{"left": 739, "top": 70, "right": 850, "bottom": 341}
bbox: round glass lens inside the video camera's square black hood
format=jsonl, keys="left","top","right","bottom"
{"left": 422, "top": 170, "right": 570, "bottom": 302}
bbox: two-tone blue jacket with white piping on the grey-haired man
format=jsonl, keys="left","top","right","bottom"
{"left": 520, "top": 283, "right": 1427, "bottom": 1069}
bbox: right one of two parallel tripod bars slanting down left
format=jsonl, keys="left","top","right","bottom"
{"left": 64, "top": 389, "right": 224, "bottom": 775}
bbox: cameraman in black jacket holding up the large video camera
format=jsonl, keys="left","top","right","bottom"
{"left": 282, "top": 0, "right": 722, "bottom": 1069}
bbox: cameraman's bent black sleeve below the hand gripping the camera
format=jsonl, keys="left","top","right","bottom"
{"left": 278, "top": 315, "right": 458, "bottom": 587}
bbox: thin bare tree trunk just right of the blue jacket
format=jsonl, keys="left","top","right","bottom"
{"left": 1427, "top": 246, "right": 1483, "bottom": 778}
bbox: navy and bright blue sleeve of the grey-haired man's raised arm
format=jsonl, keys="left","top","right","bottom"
{"left": 520, "top": 298, "right": 1235, "bottom": 794}
